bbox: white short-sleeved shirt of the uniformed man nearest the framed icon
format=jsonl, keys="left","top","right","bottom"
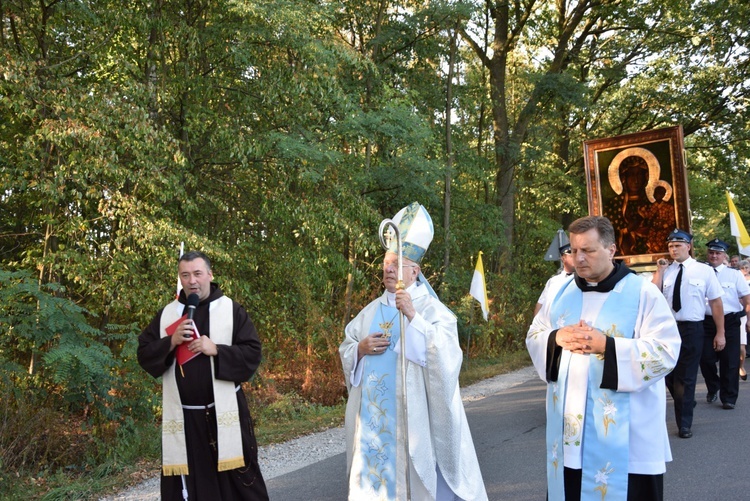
{"left": 662, "top": 257, "right": 723, "bottom": 322}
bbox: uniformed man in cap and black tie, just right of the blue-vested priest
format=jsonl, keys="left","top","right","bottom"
{"left": 652, "top": 228, "right": 725, "bottom": 438}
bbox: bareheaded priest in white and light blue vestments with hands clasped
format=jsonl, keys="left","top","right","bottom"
{"left": 526, "top": 216, "right": 681, "bottom": 501}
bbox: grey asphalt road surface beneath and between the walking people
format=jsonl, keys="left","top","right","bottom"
{"left": 267, "top": 368, "right": 750, "bottom": 501}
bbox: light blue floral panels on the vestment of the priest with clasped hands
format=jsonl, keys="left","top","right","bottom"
{"left": 547, "top": 274, "right": 643, "bottom": 501}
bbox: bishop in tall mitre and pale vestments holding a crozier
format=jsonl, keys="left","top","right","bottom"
{"left": 339, "top": 202, "right": 487, "bottom": 501}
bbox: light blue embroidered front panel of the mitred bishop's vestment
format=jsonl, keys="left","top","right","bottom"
{"left": 359, "top": 303, "right": 400, "bottom": 500}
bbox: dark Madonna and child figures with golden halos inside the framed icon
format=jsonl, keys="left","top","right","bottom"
{"left": 602, "top": 147, "right": 676, "bottom": 256}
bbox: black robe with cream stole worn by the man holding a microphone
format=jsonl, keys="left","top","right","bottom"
{"left": 138, "top": 283, "right": 268, "bottom": 501}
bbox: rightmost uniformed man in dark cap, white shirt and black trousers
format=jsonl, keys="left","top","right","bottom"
{"left": 701, "top": 238, "right": 750, "bottom": 409}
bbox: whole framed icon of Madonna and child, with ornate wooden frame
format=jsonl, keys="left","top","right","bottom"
{"left": 583, "top": 125, "right": 690, "bottom": 271}
